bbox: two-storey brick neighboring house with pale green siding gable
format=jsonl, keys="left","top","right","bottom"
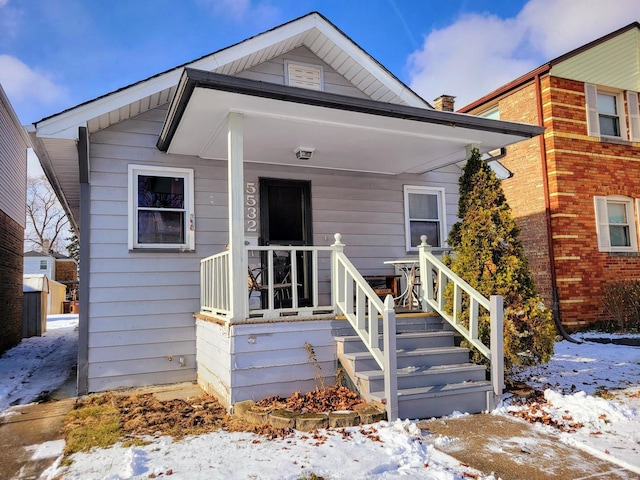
{"left": 458, "top": 22, "right": 640, "bottom": 330}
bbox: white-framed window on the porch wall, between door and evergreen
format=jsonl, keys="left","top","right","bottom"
{"left": 404, "top": 185, "right": 446, "bottom": 252}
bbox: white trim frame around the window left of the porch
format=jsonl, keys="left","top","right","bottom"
{"left": 128, "top": 164, "right": 195, "bottom": 250}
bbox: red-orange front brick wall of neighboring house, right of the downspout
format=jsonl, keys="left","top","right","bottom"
{"left": 545, "top": 77, "right": 640, "bottom": 329}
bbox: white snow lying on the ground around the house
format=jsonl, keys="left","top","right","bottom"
{"left": 0, "top": 315, "right": 640, "bottom": 480}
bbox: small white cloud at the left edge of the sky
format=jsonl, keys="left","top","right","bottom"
{"left": 0, "top": 55, "right": 67, "bottom": 105}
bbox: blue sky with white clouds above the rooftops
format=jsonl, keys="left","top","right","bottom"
{"left": 0, "top": 0, "right": 640, "bottom": 124}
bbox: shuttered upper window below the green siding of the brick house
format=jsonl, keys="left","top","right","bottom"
{"left": 584, "top": 83, "right": 640, "bottom": 142}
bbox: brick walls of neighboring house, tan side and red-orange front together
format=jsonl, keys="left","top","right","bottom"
{"left": 464, "top": 76, "right": 640, "bottom": 330}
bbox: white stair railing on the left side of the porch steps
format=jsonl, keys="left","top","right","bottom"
{"left": 332, "top": 233, "right": 398, "bottom": 421}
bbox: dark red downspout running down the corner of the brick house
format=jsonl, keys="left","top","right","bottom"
{"left": 534, "top": 72, "right": 580, "bottom": 343}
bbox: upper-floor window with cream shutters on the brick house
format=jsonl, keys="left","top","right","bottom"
{"left": 585, "top": 83, "right": 637, "bottom": 140}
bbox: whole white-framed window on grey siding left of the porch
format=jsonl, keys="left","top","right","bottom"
{"left": 129, "top": 165, "right": 194, "bottom": 250}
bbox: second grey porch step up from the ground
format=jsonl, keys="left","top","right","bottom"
{"left": 355, "top": 363, "right": 486, "bottom": 392}
